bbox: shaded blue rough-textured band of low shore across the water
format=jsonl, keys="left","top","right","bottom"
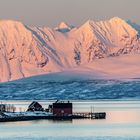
{"left": 0, "top": 79, "right": 140, "bottom": 100}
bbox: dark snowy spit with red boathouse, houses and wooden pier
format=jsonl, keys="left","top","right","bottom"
{"left": 0, "top": 100, "right": 106, "bottom": 121}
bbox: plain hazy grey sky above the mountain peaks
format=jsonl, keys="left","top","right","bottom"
{"left": 0, "top": 0, "right": 140, "bottom": 27}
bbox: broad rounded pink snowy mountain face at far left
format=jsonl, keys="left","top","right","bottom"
{"left": 0, "top": 21, "right": 62, "bottom": 81}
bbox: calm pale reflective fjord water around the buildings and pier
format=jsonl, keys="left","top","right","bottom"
{"left": 0, "top": 101, "right": 140, "bottom": 140}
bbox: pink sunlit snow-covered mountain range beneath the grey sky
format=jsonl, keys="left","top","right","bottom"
{"left": 0, "top": 17, "right": 140, "bottom": 82}
